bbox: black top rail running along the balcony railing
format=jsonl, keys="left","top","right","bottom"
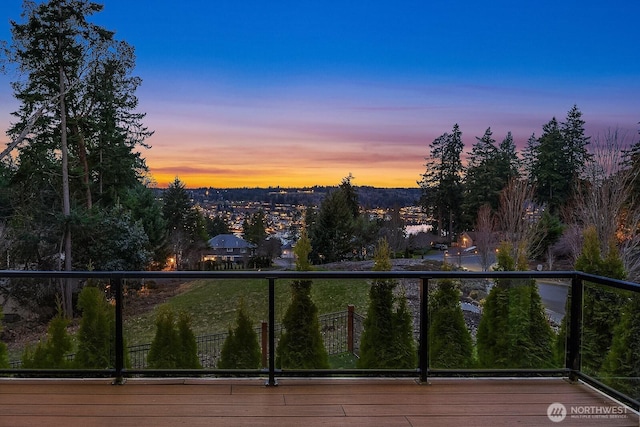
{"left": 0, "top": 270, "right": 640, "bottom": 292}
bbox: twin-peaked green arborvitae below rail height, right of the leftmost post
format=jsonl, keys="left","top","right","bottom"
{"left": 147, "top": 304, "right": 201, "bottom": 369}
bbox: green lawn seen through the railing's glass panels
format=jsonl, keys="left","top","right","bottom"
{"left": 124, "top": 279, "right": 369, "bottom": 345}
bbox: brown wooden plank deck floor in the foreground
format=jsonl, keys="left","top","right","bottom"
{"left": 0, "top": 378, "right": 640, "bottom": 427}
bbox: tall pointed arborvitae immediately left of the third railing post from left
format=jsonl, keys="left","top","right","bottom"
{"left": 358, "top": 239, "right": 417, "bottom": 369}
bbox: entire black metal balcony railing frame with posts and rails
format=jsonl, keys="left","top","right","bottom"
{"left": 0, "top": 270, "right": 640, "bottom": 411}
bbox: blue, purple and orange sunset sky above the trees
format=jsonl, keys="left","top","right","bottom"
{"left": 0, "top": 0, "right": 640, "bottom": 188}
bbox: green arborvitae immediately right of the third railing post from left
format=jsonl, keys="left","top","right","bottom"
{"left": 429, "top": 266, "right": 473, "bottom": 369}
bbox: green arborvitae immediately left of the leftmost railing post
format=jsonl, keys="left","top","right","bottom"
{"left": 74, "top": 286, "right": 115, "bottom": 369}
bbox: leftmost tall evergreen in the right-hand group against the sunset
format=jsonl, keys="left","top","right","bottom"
{"left": 419, "top": 124, "right": 464, "bottom": 239}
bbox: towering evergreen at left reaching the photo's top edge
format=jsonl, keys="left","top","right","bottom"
{"left": 1, "top": 0, "right": 151, "bottom": 317}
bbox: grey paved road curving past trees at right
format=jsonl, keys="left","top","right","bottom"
{"left": 425, "top": 251, "right": 569, "bottom": 323}
